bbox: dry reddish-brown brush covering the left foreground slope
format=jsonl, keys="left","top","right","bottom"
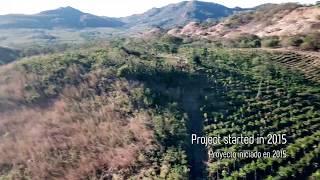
{"left": 0, "top": 65, "right": 154, "bottom": 179}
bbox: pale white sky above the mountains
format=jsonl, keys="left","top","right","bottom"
{"left": 0, "top": 0, "right": 317, "bottom": 17}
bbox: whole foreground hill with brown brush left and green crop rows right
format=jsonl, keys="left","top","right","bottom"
{"left": 0, "top": 37, "right": 320, "bottom": 180}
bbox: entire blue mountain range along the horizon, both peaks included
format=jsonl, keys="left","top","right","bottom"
{"left": 0, "top": 1, "right": 246, "bottom": 29}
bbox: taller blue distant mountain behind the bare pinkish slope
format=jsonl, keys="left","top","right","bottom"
{"left": 121, "top": 1, "right": 246, "bottom": 28}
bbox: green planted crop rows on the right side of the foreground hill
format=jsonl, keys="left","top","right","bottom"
{"left": 192, "top": 48, "right": 320, "bottom": 179}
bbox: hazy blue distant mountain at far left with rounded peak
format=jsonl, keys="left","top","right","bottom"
{"left": 0, "top": 7, "right": 123, "bottom": 28}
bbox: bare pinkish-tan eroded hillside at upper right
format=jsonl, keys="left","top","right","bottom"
{"left": 168, "top": 3, "right": 320, "bottom": 39}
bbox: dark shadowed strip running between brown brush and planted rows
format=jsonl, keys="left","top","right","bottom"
{"left": 126, "top": 70, "right": 209, "bottom": 179}
